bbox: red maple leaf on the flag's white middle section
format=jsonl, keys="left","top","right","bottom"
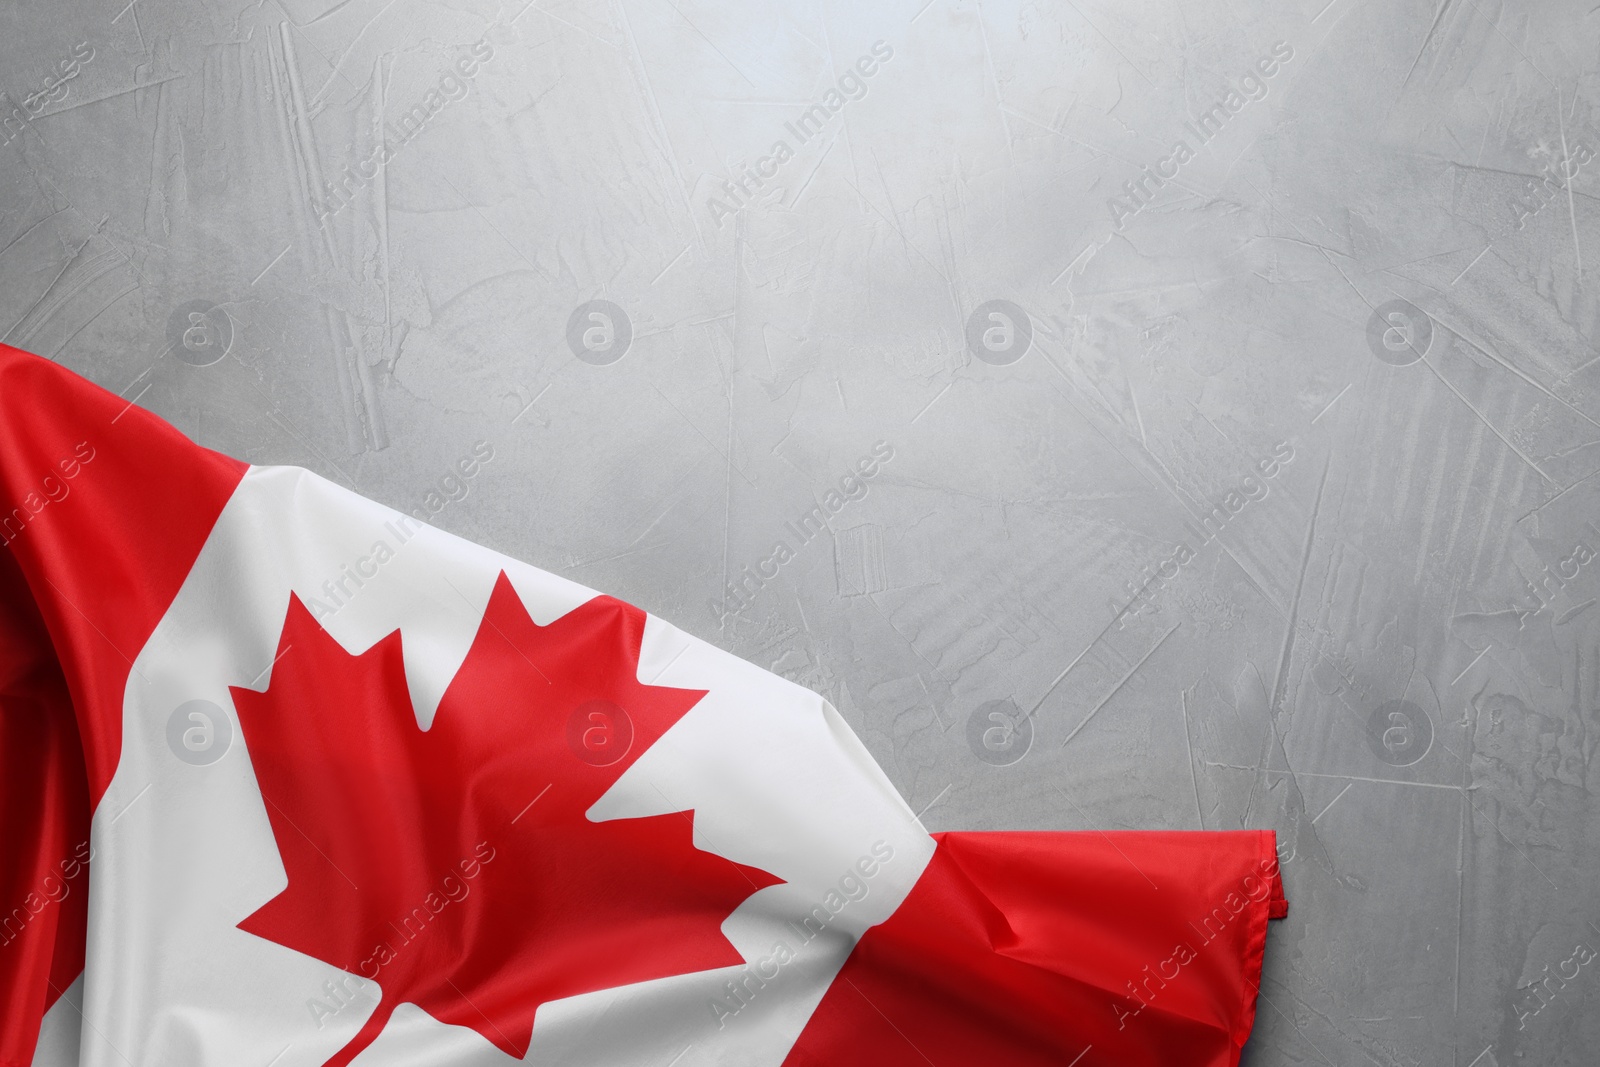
{"left": 234, "top": 574, "right": 779, "bottom": 1067}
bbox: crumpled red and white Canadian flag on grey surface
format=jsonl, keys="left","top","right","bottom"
{"left": 0, "top": 346, "right": 1286, "bottom": 1067}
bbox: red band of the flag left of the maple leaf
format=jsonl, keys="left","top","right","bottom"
{"left": 0, "top": 344, "right": 245, "bottom": 1067}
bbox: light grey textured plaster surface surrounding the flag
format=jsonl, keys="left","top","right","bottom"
{"left": 0, "top": 0, "right": 1600, "bottom": 1067}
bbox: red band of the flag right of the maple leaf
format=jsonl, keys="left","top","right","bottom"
{"left": 784, "top": 830, "right": 1288, "bottom": 1067}
